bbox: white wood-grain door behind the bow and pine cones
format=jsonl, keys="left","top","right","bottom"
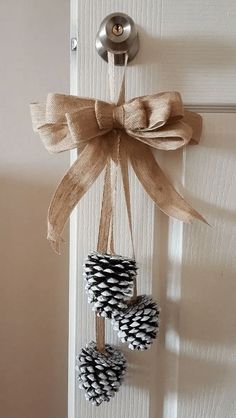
{"left": 68, "top": 0, "right": 236, "bottom": 418}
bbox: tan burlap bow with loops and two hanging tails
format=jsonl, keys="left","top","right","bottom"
{"left": 31, "top": 92, "right": 205, "bottom": 252}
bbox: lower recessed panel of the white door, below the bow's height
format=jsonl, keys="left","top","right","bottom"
{"left": 178, "top": 114, "right": 236, "bottom": 418}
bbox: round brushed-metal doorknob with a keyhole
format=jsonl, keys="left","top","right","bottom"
{"left": 95, "top": 13, "right": 139, "bottom": 65}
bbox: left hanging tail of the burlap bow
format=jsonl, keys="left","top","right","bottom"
{"left": 47, "top": 138, "right": 108, "bottom": 254}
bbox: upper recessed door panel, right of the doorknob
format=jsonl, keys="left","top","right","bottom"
{"left": 159, "top": 0, "right": 236, "bottom": 103}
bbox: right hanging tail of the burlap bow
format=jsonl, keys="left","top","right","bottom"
{"left": 126, "top": 137, "right": 208, "bottom": 224}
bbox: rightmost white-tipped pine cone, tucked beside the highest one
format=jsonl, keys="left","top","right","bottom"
{"left": 113, "top": 295, "right": 160, "bottom": 350}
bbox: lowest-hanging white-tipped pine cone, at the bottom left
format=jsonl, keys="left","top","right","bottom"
{"left": 76, "top": 341, "right": 126, "bottom": 406}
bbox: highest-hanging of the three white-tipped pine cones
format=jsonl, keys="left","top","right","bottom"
{"left": 84, "top": 252, "right": 137, "bottom": 318}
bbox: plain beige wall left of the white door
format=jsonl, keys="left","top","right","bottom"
{"left": 0, "top": 0, "right": 69, "bottom": 418}
